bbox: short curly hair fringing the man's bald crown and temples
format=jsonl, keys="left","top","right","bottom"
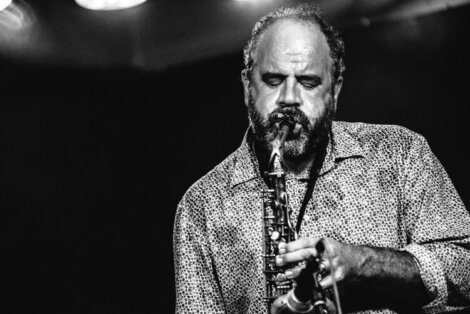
{"left": 242, "top": 4, "right": 346, "bottom": 82}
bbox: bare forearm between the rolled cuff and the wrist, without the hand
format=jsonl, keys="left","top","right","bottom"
{"left": 339, "top": 246, "right": 430, "bottom": 311}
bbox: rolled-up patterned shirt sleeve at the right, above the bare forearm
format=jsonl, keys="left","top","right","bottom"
{"left": 402, "top": 136, "right": 470, "bottom": 313}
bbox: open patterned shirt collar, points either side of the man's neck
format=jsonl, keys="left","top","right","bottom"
{"left": 230, "top": 121, "right": 365, "bottom": 187}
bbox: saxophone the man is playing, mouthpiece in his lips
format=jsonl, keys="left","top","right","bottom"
{"left": 262, "top": 113, "right": 328, "bottom": 314}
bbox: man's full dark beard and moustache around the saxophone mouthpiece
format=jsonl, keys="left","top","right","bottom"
{"left": 248, "top": 95, "right": 335, "bottom": 163}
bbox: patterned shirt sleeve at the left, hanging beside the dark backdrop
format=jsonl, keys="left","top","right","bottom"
{"left": 173, "top": 197, "right": 225, "bottom": 313}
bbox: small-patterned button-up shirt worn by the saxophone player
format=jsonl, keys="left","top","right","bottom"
{"left": 173, "top": 122, "right": 470, "bottom": 314}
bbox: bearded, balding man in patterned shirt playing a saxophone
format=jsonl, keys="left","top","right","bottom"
{"left": 174, "top": 5, "right": 470, "bottom": 313}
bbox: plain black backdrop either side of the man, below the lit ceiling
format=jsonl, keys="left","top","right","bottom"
{"left": 0, "top": 5, "right": 470, "bottom": 313}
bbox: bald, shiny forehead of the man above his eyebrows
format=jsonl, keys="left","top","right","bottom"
{"left": 255, "top": 19, "right": 331, "bottom": 71}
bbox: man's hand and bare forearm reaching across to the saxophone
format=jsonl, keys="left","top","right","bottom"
{"left": 276, "top": 237, "right": 432, "bottom": 311}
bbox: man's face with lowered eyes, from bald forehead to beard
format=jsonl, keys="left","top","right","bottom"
{"left": 245, "top": 19, "right": 341, "bottom": 161}
